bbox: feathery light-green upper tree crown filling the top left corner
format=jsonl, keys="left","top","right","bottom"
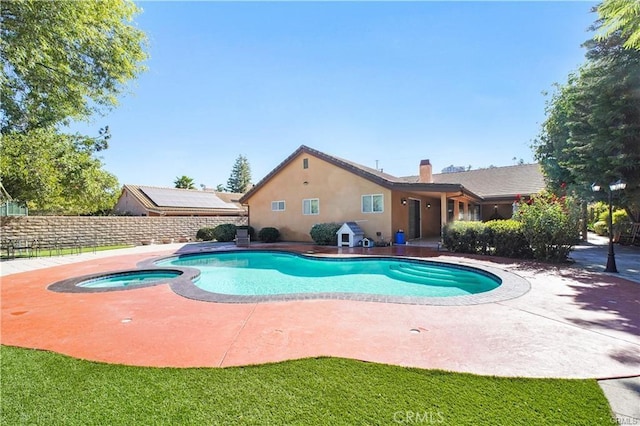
{"left": 0, "top": 0, "right": 147, "bottom": 134}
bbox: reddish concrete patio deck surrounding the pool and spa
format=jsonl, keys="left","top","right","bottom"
{"left": 0, "top": 246, "right": 640, "bottom": 378}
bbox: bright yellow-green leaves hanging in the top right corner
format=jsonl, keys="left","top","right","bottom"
{"left": 597, "top": 0, "right": 640, "bottom": 50}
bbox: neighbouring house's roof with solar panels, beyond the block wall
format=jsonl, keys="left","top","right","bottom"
{"left": 123, "top": 185, "right": 246, "bottom": 215}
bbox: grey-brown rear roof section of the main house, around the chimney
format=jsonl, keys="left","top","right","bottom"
{"left": 401, "top": 164, "right": 545, "bottom": 199}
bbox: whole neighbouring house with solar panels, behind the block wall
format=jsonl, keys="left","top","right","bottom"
{"left": 114, "top": 185, "right": 247, "bottom": 216}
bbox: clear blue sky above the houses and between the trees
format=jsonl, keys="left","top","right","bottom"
{"left": 79, "top": 1, "right": 596, "bottom": 187}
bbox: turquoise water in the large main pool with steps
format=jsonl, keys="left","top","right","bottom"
{"left": 156, "top": 251, "right": 501, "bottom": 297}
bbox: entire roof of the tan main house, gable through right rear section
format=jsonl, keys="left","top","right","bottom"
{"left": 240, "top": 145, "right": 544, "bottom": 203}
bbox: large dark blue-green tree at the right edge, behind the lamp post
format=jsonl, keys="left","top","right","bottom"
{"left": 535, "top": 27, "right": 640, "bottom": 221}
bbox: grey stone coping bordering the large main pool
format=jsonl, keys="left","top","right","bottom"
{"left": 138, "top": 249, "right": 531, "bottom": 306}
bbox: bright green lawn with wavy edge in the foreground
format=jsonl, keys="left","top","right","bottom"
{"left": 0, "top": 346, "right": 614, "bottom": 426}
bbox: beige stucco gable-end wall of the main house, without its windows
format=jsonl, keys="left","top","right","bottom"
{"left": 247, "top": 153, "right": 393, "bottom": 241}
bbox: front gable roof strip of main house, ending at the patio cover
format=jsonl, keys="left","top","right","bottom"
{"left": 240, "top": 145, "right": 481, "bottom": 203}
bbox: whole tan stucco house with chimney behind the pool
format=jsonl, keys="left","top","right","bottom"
{"left": 240, "top": 145, "right": 544, "bottom": 241}
